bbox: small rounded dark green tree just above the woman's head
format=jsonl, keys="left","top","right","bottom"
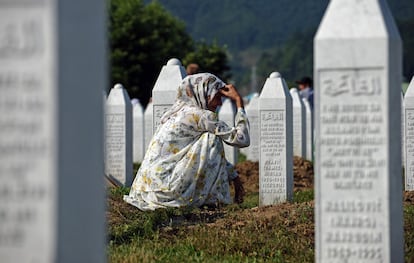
{"left": 183, "top": 41, "right": 230, "bottom": 80}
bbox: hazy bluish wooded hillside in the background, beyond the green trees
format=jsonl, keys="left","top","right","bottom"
{"left": 146, "top": 0, "right": 414, "bottom": 91}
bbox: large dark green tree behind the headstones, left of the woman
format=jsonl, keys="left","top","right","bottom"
{"left": 109, "top": 0, "right": 193, "bottom": 106}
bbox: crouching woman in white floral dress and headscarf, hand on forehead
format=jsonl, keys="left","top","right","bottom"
{"left": 124, "top": 73, "right": 250, "bottom": 210}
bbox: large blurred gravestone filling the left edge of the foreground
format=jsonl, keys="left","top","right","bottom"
{"left": 0, "top": 0, "right": 107, "bottom": 263}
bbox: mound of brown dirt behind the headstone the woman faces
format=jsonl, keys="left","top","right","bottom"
{"left": 236, "top": 156, "right": 314, "bottom": 193}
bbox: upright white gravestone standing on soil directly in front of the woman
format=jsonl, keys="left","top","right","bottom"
{"left": 259, "top": 72, "right": 293, "bottom": 206}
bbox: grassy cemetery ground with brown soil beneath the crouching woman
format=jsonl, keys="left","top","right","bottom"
{"left": 107, "top": 157, "right": 414, "bottom": 262}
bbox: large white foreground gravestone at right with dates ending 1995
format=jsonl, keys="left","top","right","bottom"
{"left": 314, "top": 0, "right": 404, "bottom": 262}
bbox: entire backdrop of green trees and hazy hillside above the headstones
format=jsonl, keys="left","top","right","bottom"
{"left": 109, "top": 0, "right": 414, "bottom": 106}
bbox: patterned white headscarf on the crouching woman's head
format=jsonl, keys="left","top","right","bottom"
{"left": 161, "top": 73, "right": 225, "bottom": 123}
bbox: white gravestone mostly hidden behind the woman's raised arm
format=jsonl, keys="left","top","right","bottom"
{"left": 218, "top": 99, "right": 238, "bottom": 165}
